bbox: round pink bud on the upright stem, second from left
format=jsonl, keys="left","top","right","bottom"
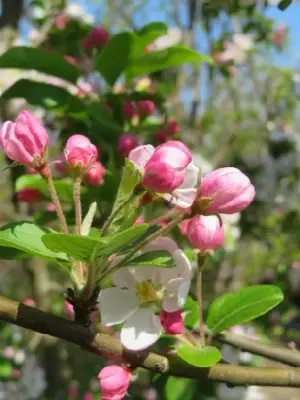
{"left": 64, "top": 135, "right": 98, "bottom": 171}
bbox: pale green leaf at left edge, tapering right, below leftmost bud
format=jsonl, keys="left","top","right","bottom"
{"left": 0, "top": 221, "right": 68, "bottom": 261}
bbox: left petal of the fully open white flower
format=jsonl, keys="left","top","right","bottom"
{"left": 98, "top": 288, "right": 139, "bottom": 326}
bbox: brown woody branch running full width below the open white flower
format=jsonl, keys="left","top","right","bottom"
{"left": 0, "top": 296, "right": 300, "bottom": 388}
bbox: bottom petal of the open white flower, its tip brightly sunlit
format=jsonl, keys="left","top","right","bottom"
{"left": 121, "top": 308, "right": 162, "bottom": 350}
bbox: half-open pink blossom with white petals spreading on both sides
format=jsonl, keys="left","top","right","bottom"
{"left": 128, "top": 140, "right": 199, "bottom": 208}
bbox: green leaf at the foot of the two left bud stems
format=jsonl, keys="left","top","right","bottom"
{"left": 42, "top": 233, "right": 108, "bottom": 261}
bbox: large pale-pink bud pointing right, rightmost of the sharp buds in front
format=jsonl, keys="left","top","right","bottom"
{"left": 197, "top": 167, "right": 255, "bottom": 214}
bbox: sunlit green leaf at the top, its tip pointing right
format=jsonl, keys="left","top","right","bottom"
{"left": 127, "top": 46, "right": 213, "bottom": 79}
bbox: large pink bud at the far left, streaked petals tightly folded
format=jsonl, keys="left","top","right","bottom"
{"left": 0, "top": 111, "right": 49, "bottom": 168}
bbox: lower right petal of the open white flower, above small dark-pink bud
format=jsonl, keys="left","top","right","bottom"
{"left": 163, "top": 279, "right": 191, "bottom": 312}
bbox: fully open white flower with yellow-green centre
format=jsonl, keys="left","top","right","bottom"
{"left": 98, "top": 237, "right": 192, "bottom": 350}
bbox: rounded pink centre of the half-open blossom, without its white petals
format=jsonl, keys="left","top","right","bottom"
{"left": 143, "top": 141, "right": 192, "bottom": 193}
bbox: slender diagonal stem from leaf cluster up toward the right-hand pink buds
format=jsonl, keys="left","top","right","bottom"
{"left": 100, "top": 211, "right": 185, "bottom": 280}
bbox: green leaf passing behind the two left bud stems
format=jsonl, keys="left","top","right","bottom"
{"left": 15, "top": 174, "right": 86, "bottom": 201}
